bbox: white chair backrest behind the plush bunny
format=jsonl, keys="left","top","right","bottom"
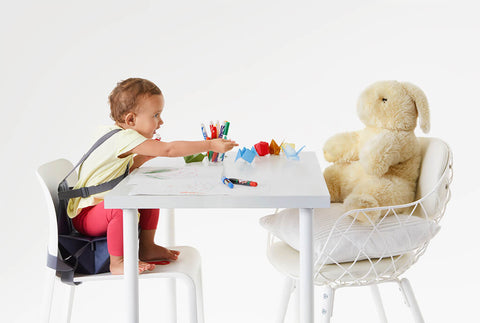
{"left": 416, "top": 137, "right": 452, "bottom": 220}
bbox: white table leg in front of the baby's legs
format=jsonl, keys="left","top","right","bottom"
{"left": 123, "top": 209, "right": 139, "bottom": 323}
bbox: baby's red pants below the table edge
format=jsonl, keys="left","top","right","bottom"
{"left": 72, "top": 202, "right": 159, "bottom": 256}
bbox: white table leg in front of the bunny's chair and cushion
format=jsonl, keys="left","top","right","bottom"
{"left": 299, "top": 209, "right": 314, "bottom": 323}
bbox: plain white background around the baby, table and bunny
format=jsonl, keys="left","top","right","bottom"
{"left": 0, "top": 0, "right": 480, "bottom": 322}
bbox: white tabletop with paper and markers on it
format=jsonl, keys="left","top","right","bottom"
{"left": 105, "top": 152, "right": 330, "bottom": 209}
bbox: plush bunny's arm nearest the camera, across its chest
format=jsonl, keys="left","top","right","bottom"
{"left": 359, "top": 131, "right": 415, "bottom": 176}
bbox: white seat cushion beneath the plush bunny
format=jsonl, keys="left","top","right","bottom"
{"left": 260, "top": 203, "right": 440, "bottom": 264}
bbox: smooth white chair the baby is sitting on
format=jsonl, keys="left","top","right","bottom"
{"left": 37, "top": 159, "right": 203, "bottom": 322}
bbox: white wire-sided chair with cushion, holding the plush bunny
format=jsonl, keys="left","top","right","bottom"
{"left": 260, "top": 138, "right": 453, "bottom": 323}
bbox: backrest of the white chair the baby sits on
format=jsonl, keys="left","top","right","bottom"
{"left": 37, "top": 159, "right": 77, "bottom": 255}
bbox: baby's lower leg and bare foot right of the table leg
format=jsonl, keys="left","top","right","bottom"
{"left": 138, "top": 209, "right": 180, "bottom": 261}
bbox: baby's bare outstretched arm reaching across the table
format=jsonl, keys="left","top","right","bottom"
{"left": 129, "top": 139, "right": 238, "bottom": 157}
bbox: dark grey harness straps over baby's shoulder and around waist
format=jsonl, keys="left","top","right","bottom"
{"left": 58, "top": 129, "right": 129, "bottom": 200}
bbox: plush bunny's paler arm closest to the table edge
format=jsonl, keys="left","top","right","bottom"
{"left": 323, "top": 131, "right": 359, "bottom": 163}
